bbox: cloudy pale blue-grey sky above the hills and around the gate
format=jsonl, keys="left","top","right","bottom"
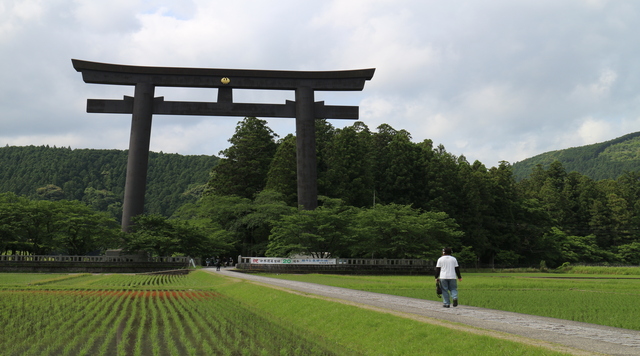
{"left": 0, "top": 0, "right": 640, "bottom": 166}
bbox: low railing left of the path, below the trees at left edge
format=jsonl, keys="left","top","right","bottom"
{"left": 0, "top": 255, "right": 191, "bottom": 264}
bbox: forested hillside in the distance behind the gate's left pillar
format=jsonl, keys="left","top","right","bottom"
{"left": 0, "top": 146, "right": 218, "bottom": 217}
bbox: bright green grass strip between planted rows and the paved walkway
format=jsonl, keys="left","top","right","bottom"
{"left": 210, "top": 276, "right": 566, "bottom": 355}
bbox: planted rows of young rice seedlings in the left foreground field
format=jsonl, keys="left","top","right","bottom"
{"left": 0, "top": 290, "right": 336, "bottom": 355}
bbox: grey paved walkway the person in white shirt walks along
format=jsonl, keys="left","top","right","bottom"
{"left": 214, "top": 268, "right": 640, "bottom": 355}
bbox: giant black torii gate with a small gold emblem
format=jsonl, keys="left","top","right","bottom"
{"left": 71, "top": 59, "right": 375, "bottom": 231}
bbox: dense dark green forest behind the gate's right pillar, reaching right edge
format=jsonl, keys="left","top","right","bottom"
{"left": 0, "top": 118, "right": 640, "bottom": 267}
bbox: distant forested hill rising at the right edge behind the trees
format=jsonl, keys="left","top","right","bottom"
{"left": 513, "top": 132, "right": 640, "bottom": 180}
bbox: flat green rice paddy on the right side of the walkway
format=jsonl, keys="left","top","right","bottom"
{"left": 265, "top": 268, "right": 640, "bottom": 330}
